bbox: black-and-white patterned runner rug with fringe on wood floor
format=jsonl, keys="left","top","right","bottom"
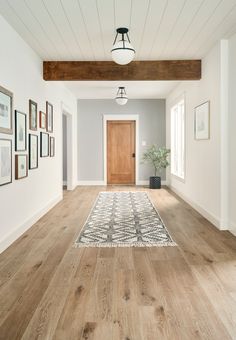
{"left": 75, "top": 191, "right": 176, "bottom": 247}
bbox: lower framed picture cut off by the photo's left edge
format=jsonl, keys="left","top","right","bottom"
{"left": 0, "top": 139, "right": 12, "bottom": 185}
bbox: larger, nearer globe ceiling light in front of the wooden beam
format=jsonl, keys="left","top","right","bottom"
{"left": 111, "top": 27, "right": 135, "bottom": 65}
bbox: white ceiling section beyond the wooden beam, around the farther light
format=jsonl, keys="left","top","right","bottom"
{"left": 64, "top": 81, "right": 179, "bottom": 99}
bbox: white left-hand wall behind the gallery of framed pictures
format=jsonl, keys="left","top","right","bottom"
{"left": 0, "top": 16, "right": 77, "bottom": 251}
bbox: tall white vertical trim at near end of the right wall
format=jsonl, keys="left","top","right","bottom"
{"left": 220, "top": 40, "right": 229, "bottom": 228}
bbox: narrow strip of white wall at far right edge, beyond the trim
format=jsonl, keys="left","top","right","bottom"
{"left": 228, "top": 34, "right": 236, "bottom": 235}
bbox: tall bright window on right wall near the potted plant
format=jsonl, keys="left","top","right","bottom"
{"left": 171, "top": 97, "right": 185, "bottom": 179}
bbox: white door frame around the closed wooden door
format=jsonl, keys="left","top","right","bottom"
{"left": 103, "top": 113, "right": 139, "bottom": 185}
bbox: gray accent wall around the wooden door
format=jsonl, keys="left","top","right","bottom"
{"left": 78, "top": 99, "right": 166, "bottom": 181}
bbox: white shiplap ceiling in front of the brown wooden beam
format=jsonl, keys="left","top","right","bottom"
{"left": 0, "top": 0, "right": 236, "bottom": 60}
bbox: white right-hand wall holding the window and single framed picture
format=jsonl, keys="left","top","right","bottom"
{"left": 166, "top": 44, "right": 221, "bottom": 227}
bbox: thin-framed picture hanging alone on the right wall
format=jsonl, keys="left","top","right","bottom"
{"left": 194, "top": 101, "right": 210, "bottom": 140}
